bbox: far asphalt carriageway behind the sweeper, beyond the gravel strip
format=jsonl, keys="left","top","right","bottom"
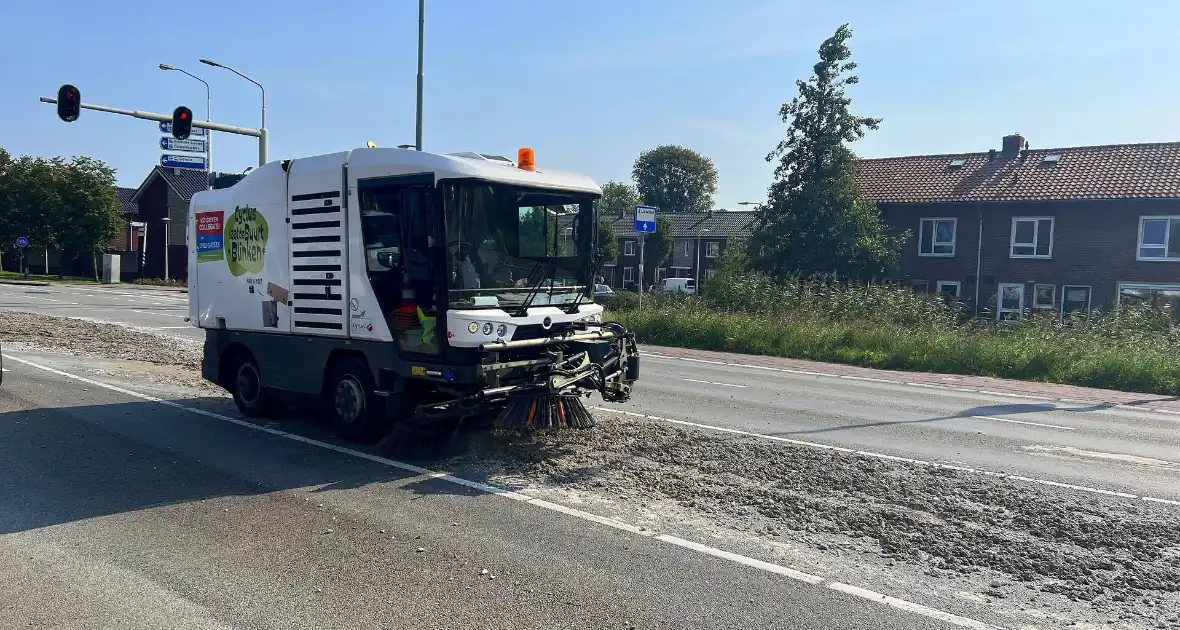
{"left": 0, "top": 286, "right": 1180, "bottom": 500}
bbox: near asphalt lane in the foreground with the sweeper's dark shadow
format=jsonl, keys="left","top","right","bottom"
{"left": 0, "top": 349, "right": 948, "bottom": 630}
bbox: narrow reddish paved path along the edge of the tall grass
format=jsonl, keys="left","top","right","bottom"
{"left": 640, "top": 344, "right": 1180, "bottom": 414}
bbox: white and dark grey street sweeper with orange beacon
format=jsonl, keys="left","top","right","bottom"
{"left": 188, "top": 147, "right": 638, "bottom": 455}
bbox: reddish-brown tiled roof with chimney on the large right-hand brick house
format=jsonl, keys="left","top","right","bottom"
{"left": 857, "top": 143, "right": 1180, "bottom": 203}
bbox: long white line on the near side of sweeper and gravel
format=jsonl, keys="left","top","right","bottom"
{"left": 4, "top": 355, "right": 1005, "bottom": 630}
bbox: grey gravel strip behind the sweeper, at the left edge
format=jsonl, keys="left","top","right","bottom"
{"left": 0, "top": 310, "right": 201, "bottom": 369}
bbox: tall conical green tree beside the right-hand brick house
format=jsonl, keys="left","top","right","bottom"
{"left": 750, "top": 24, "right": 909, "bottom": 278}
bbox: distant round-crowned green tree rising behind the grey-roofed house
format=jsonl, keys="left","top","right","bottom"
{"left": 631, "top": 144, "right": 717, "bottom": 214}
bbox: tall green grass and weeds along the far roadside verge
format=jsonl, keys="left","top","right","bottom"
{"left": 608, "top": 274, "right": 1180, "bottom": 394}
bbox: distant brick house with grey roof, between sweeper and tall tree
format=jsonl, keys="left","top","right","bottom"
{"left": 601, "top": 210, "right": 754, "bottom": 289}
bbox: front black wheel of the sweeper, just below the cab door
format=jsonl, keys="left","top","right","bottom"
{"left": 325, "top": 356, "right": 392, "bottom": 444}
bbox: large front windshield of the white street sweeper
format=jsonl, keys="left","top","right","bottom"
{"left": 444, "top": 182, "right": 597, "bottom": 311}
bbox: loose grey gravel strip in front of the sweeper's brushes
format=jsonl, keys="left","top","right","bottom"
{"left": 448, "top": 418, "right": 1180, "bottom": 603}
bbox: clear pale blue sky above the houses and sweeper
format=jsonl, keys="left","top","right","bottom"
{"left": 0, "top": 0, "right": 1180, "bottom": 210}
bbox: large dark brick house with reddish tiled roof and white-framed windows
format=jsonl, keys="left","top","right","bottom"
{"left": 857, "top": 134, "right": 1180, "bottom": 319}
